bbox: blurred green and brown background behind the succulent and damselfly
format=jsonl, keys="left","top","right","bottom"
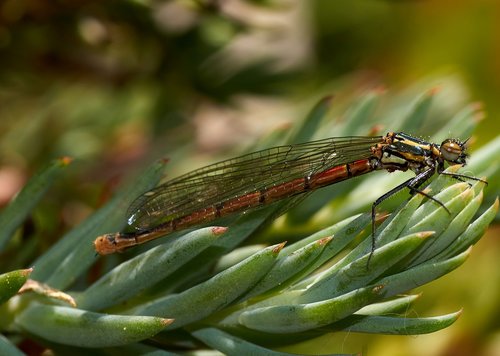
{"left": 0, "top": 0, "right": 500, "bottom": 355}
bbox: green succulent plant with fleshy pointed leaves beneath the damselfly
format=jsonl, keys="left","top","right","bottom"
{"left": 0, "top": 88, "right": 500, "bottom": 354}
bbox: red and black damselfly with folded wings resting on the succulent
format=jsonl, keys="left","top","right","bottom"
{"left": 94, "top": 132, "right": 480, "bottom": 255}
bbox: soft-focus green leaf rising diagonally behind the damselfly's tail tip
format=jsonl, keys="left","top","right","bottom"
{"left": 32, "top": 160, "right": 166, "bottom": 289}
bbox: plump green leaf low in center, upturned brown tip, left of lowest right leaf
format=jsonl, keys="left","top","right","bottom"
{"left": 239, "top": 287, "right": 382, "bottom": 333}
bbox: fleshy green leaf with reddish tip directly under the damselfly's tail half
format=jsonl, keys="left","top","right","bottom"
{"left": 77, "top": 227, "right": 226, "bottom": 310}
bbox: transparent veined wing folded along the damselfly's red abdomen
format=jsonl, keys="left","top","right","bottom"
{"left": 127, "top": 136, "right": 381, "bottom": 231}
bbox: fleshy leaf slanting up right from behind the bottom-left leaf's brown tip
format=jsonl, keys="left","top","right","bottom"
{"left": 134, "top": 244, "right": 283, "bottom": 328}
